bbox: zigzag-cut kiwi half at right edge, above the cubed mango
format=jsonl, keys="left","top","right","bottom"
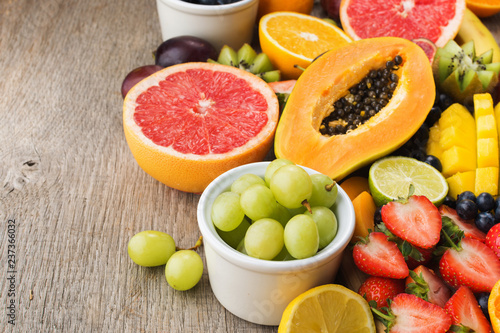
{"left": 432, "top": 40, "right": 500, "bottom": 105}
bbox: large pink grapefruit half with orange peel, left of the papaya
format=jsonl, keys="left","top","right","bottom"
{"left": 123, "top": 63, "right": 279, "bottom": 193}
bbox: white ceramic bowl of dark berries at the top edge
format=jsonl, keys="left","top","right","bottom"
{"left": 156, "top": 0, "right": 259, "bottom": 50}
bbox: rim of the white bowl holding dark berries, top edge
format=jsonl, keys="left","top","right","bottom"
{"left": 157, "top": 0, "right": 258, "bottom": 15}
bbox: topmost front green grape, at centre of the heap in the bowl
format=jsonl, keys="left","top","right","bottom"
{"left": 270, "top": 165, "right": 312, "bottom": 209}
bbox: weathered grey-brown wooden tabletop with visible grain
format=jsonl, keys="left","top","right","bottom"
{"left": 0, "top": 0, "right": 500, "bottom": 333}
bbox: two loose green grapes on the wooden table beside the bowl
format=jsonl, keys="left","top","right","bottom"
{"left": 128, "top": 230, "right": 203, "bottom": 290}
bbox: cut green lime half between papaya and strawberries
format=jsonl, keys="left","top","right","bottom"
{"left": 368, "top": 156, "right": 448, "bottom": 206}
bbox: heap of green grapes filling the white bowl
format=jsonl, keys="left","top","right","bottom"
{"left": 211, "top": 159, "right": 338, "bottom": 260}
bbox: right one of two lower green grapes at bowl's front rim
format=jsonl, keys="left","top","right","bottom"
{"left": 284, "top": 214, "right": 319, "bottom": 259}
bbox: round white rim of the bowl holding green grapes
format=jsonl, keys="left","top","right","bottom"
{"left": 197, "top": 161, "right": 355, "bottom": 273}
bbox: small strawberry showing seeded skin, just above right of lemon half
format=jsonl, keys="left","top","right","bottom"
{"left": 358, "top": 276, "right": 405, "bottom": 308}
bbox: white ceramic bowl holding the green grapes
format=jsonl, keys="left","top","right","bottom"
{"left": 197, "top": 162, "right": 355, "bottom": 325}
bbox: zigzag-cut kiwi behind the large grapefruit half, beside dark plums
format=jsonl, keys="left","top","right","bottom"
{"left": 207, "top": 43, "right": 281, "bottom": 82}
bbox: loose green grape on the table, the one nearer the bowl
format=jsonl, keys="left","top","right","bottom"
{"left": 165, "top": 250, "right": 203, "bottom": 290}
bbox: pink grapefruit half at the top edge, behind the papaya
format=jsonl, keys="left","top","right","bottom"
{"left": 340, "top": 0, "right": 465, "bottom": 47}
